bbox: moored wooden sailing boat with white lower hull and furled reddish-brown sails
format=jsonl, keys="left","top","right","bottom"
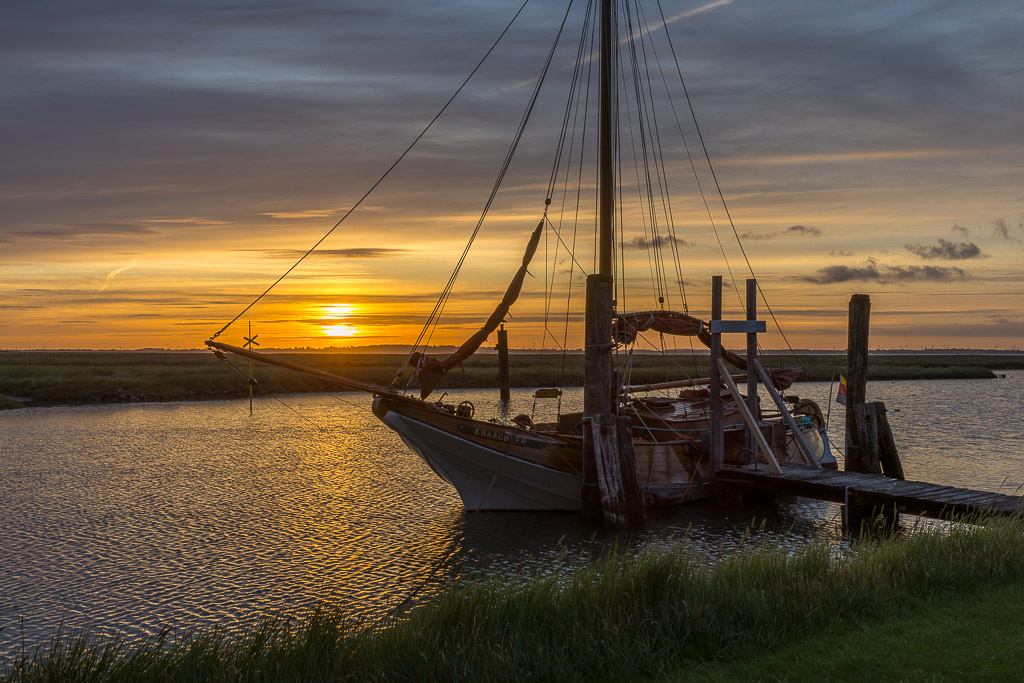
{"left": 206, "top": 0, "right": 835, "bottom": 510}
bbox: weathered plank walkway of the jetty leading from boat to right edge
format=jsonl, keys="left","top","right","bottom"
{"left": 716, "top": 465, "right": 1024, "bottom": 519}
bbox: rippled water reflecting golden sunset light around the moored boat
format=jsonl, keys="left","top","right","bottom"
{"left": 0, "top": 372, "right": 1024, "bottom": 665}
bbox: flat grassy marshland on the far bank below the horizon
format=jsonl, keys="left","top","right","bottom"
{"left": 0, "top": 351, "right": 1024, "bottom": 409}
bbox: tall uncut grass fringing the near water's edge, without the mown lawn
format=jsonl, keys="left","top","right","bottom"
{"left": 3, "top": 518, "right": 1024, "bottom": 682}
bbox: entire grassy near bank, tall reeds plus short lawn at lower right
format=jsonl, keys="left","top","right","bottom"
{"left": 8, "top": 518, "right": 1024, "bottom": 683}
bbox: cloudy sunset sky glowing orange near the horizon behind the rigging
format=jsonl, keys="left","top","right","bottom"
{"left": 0, "top": 0, "right": 1024, "bottom": 349}
